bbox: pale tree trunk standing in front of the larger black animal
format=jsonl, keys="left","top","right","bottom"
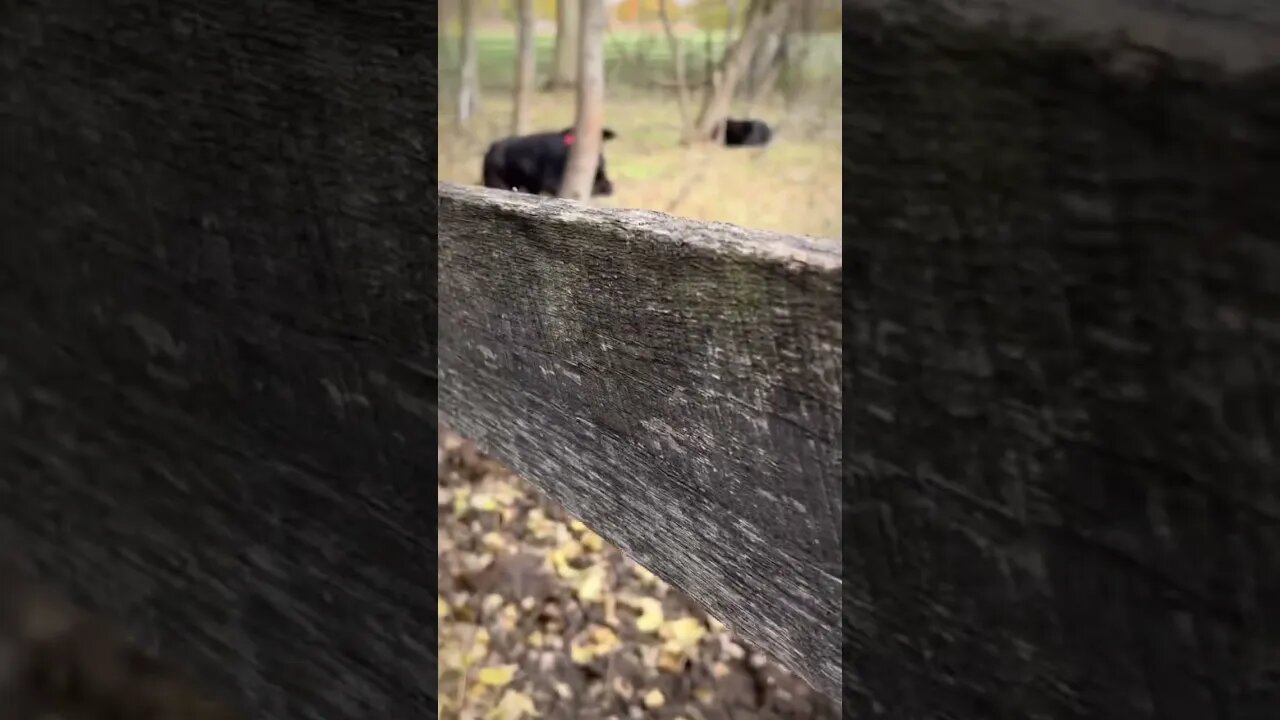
{"left": 561, "top": 0, "right": 604, "bottom": 200}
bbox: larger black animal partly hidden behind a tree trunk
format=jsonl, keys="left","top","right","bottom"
{"left": 484, "top": 128, "right": 617, "bottom": 197}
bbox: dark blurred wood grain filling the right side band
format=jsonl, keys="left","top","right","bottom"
{"left": 844, "top": 0, "right": 1280, "bottom": 720}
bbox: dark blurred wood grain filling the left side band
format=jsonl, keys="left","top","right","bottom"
{"left": 0, "top": 0, "right": 435, "bottom": 720}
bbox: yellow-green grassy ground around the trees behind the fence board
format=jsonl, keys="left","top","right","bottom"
{"left": 439, "top": 31, "right": 841, "bottom": 238}
